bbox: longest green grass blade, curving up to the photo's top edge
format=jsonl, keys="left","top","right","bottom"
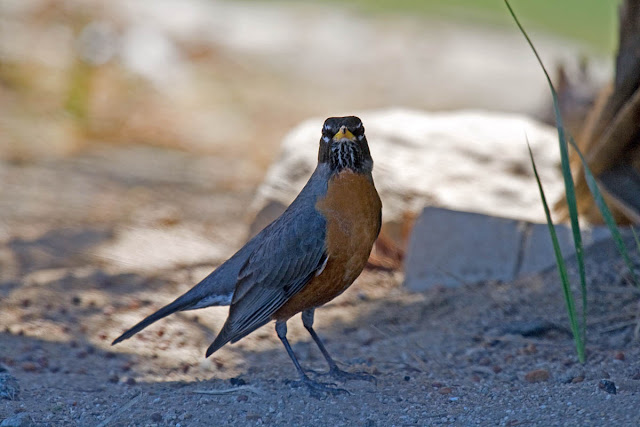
{"left": 504, "top": 0, "right": 587, "bottom": 352}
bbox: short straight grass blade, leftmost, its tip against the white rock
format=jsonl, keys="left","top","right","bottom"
{"left": 527, "top": 140, "right": 585, "bottom": 363}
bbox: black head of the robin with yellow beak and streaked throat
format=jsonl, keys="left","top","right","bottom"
{"left": 318, "top": 116, "right": 373, "bottom": 173}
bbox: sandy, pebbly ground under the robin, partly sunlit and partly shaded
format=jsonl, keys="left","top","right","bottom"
{"left": 0, "top": 147, "right": 640, "bottom": 426}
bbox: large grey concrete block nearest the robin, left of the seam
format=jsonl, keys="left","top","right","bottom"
{"left": 405, "top": 207, "right": 524, "bottom": 291}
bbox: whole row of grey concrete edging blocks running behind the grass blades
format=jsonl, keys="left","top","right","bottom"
{"left": 405, "top": 207, "right": 630, "bottom": 291}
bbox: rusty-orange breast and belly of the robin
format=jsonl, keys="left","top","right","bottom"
{"left": 273, "top": 170, "right": 382, "bottom": 320}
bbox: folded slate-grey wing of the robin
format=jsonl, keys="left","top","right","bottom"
{"left": 207, "top": 207, "right": 326, "bottom": 357}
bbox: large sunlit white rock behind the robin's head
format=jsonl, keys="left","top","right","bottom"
{"left": 252, "top": 110, "right": 563, "bottom": 222}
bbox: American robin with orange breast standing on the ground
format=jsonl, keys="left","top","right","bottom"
{"left": 113, "top": 116, "right": 382, "bottom": 392}
